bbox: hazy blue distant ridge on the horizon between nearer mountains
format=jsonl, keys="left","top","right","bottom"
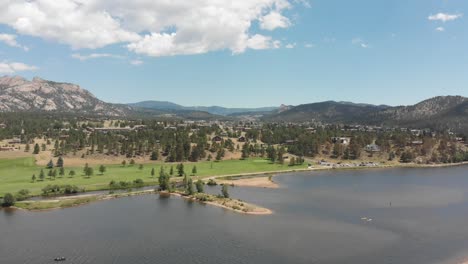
{"left": 128, "top": 101, "right": 279, "bottom": 116}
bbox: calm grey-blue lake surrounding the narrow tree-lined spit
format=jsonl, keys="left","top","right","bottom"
{"left": 0, "top": 166, "right": 468, "bottom": 264}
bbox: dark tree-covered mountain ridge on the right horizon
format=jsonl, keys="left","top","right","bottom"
{"left": 263, "top": 96, "right": 468, "bottom": 131}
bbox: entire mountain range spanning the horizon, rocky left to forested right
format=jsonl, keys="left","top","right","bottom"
{"left": 0, "top": 76, "right": 468, "bottom": 132}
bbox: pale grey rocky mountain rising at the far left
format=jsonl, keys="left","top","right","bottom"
{"left": 0, "top": 76, "right": 131, "bottom": 116}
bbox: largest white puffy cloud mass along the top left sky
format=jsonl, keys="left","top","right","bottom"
{"left": 0, "top": 0, "right": 302, "bottom": 56}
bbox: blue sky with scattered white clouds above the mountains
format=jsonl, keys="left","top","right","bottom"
{"left": 0, "top": 0, "right": 468, "bottom": 107}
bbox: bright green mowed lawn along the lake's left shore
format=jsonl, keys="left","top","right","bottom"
{"left": 0, "top": 157, "right": 306, "bottom": 197}
